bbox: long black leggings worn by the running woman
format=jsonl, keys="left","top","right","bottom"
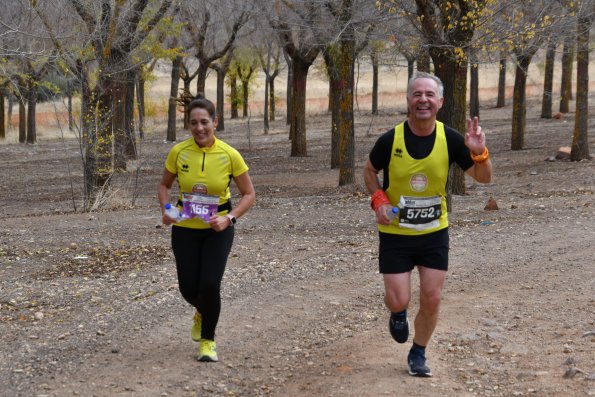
{"left": 171, "top": 226, "right": 234, "bottom": 339}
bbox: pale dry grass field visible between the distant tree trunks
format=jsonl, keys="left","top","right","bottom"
{"left": 0, "top": 54, "right": 595, "bottom": 144}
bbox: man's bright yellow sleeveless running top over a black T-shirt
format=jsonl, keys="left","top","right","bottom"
{"left": 378, "top": 121, "right": 449, "bottom": 236}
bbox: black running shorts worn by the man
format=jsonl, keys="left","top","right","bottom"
{"left": 378, "top": 228, "right": 448, "bottom": 274}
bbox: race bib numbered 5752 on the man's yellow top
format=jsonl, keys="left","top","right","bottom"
{"left": 399, "top": 196, "right": 442, "bottom": 230}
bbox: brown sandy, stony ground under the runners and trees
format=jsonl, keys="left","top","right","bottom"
{"left": 0, "top": 60, "right": 595, "bottom": 396}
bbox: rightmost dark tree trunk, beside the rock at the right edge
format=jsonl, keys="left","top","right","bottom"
{"left": 570, "top": 16, "right": 591, "bottom": 161}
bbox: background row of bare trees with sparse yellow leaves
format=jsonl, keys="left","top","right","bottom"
{"left": 0, "top": 0, "right": 595, "bottom": 209}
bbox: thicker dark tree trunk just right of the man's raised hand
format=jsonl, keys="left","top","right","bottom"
{"left": 510, "top": 55, "right": 531, "bottom": 150}
